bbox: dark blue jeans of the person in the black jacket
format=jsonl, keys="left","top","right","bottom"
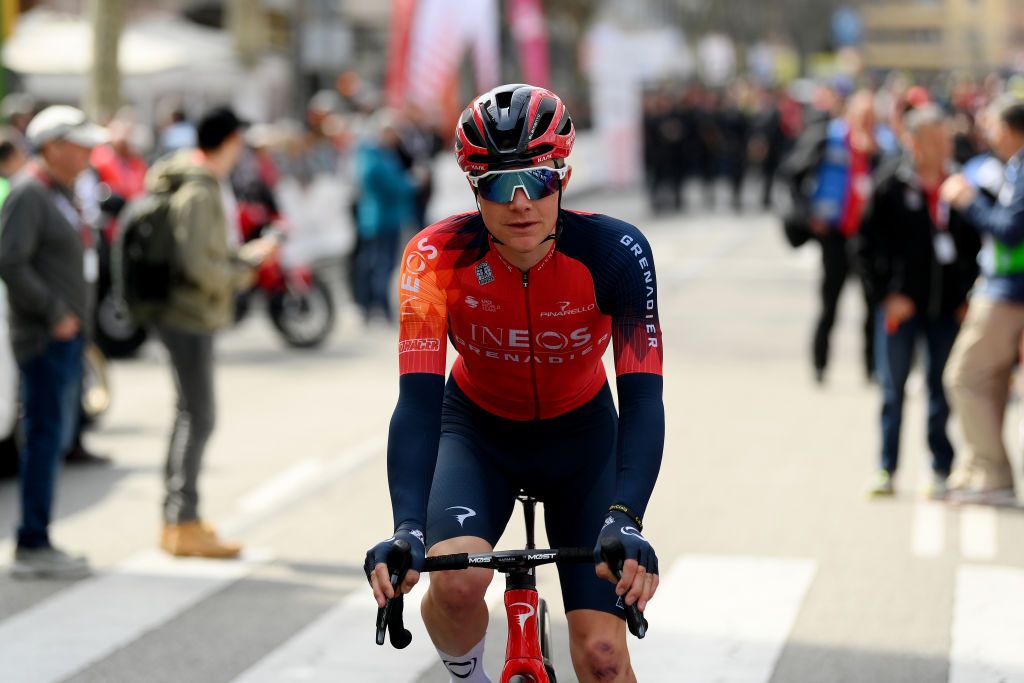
{"left": 876, "top": 310, "right": 959, "bottom": 475}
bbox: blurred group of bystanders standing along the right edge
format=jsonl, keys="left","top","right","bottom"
{"left": 770, "top": 70, "right": 1024, "bottom": 505}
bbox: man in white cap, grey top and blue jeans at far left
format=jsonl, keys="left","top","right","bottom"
{"left": 0, "top": 105, "right": 105, "bottom": 579}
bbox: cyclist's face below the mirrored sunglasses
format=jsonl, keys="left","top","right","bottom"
{"left": 479, "top": 162, "right": 568, "bottom": 255}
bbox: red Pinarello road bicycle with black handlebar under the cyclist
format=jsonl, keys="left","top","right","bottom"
{"left": 377, "top": 493, "right": 648, "bottom": 683}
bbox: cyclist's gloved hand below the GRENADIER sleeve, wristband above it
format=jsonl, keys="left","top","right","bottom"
{"left": 594, "top": 511, "right": 658, "bottom": 611}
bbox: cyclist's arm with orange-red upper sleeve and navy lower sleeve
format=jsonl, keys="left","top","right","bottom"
{"left": 387, "top": 236, "right": 447, "bottom": 529}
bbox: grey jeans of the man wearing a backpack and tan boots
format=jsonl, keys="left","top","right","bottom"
{"left": 157, "top": 325, "right": 216, "bottom": 524}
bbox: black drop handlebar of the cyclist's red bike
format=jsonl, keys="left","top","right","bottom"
{"left": 368, "top": 540, "right": 647, "bottom": 649}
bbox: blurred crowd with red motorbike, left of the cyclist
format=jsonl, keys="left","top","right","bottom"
{"left": 0, "top": 91, "right": 442, "bottom": 579}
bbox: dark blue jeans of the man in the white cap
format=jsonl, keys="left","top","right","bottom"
{"left": 17, "top": 335, "right": 85, "bottom": 548}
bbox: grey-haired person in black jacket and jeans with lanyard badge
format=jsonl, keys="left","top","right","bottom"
{"left": 856, "top": 104, "right": 981, "bottom": 498}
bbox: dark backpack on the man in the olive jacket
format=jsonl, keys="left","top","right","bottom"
{"left": 111, "top": 191, "right": 177, "bottom": 325}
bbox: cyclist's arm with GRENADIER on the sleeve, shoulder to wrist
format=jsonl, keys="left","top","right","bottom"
{"left": 611, "top": 231, "right": 665, "bottom": 517}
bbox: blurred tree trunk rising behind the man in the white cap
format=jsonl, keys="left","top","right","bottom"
{"left": 85, "top": 0, "right": 128, "bottom": 123}
